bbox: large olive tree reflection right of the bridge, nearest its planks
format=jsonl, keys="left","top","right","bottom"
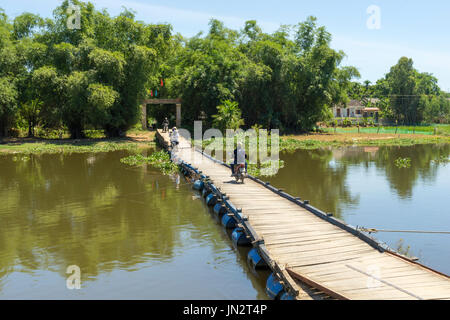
{"left": 268, "top": 149, "right": 359, "bottom": 217}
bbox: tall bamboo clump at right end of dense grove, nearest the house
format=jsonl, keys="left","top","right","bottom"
{"left": 282, "top": 17, "right": 353, "bottom": 131}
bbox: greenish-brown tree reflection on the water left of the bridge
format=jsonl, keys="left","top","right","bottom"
{"left": 0, "top": 152, "right": 222, "bottom": 278}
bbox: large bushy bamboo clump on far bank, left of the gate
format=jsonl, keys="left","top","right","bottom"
{"left": 28, "top": 1, "right": 172, "bottom": 138}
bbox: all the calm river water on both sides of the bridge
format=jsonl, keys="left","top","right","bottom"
{"left": 0, "top": 145, "right": 450, "bottom": 299}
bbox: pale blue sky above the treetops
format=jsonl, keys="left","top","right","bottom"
{"left": 0, "top": 0, "right": 450, "bottom": 91}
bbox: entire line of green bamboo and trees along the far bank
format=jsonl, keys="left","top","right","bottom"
{"left": 0, "top": 1, "right": 449, "bottom": 137}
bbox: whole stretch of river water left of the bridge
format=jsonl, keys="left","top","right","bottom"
{"left": 0, "top": 152, "right": 266, "bottom": 299}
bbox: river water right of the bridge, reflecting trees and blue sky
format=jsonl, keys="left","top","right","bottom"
{"left": 265, "top": 144, "right": 450, "bottom": 274}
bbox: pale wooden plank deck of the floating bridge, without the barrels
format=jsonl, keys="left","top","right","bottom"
{"left": 158, "top": 131, "right": 450, "bottom": 300}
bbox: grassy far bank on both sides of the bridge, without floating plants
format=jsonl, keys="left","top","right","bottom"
{"left": 0, "top": 130, "right": 450, "bottom": 155}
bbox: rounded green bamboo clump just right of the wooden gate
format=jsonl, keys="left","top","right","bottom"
{"left": 171, "top": 20, "right": 245, "bottom": 125}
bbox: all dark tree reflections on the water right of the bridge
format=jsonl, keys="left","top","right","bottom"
{"left": 268, "top": 144, "right": 450, "bottom": 216}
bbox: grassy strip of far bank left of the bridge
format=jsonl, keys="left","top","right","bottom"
{"left": 0, "top": 131, "right": 155, "bottom": 154}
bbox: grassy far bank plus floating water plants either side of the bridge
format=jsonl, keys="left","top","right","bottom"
{"left": 0, "top": 129, "right": 450, "bottom": 177}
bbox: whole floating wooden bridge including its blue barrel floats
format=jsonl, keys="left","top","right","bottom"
{"left": 157, "top": 130, "right": 450, "bottom": 300}
